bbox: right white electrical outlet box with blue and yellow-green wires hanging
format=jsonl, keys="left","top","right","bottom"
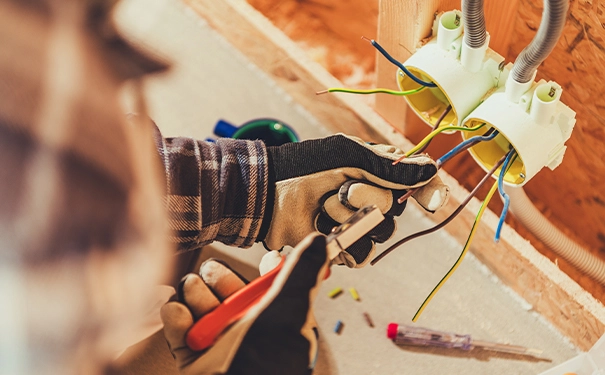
{"left": 462, "top": 80, "right": 576, "bottom": 186}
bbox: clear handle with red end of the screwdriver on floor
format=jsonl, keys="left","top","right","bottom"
{"left": 387, "top": 323, "right": 473, "bottom": 350}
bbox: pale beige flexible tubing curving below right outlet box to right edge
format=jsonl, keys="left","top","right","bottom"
{"left": 505, "top": 186, "right": 605, "bottom": 284}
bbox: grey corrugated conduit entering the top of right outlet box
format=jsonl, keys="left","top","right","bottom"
{"left": 508, "top": 0, "right": 569, "bottom": 83}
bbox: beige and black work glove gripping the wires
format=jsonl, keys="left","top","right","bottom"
{"left": 259, "top": 134, "right": 449, "bottom": 268}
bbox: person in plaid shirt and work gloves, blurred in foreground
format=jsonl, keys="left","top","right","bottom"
{"left": 0, "top": 0, "right": 447, "bottom": 374}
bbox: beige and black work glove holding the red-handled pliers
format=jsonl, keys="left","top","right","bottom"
{"left": 161, "top": 232, "right": 328, "bottom": 375}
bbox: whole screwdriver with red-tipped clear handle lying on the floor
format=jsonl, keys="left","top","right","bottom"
{"left": 387, "top": 323, "right": 542, "bottom": 357}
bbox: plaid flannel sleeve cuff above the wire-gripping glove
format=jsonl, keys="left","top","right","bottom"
{"left": 155, "top": 126, "right": 268, "bottom": 250}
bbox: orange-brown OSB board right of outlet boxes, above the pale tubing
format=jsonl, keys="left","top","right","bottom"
{"left": 509, "top": 0, "right": 605, "bottom": 301}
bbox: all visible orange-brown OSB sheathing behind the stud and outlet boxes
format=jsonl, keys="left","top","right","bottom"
{"left": 244, "top": 0, "right": 605, "bottom": 301}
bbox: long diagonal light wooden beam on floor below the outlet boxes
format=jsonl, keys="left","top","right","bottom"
{"left": 185, "top": 0, "right": 605, "bottom": 350}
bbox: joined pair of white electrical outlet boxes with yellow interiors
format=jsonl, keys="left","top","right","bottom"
{"left": 397, "top": 10, "right": 576, "bottom": 186}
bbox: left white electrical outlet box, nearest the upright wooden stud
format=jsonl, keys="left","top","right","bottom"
{"left": 397, "top": 10, "right": 506, "bottom": 133}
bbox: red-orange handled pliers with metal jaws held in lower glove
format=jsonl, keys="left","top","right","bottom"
{"left": 186, "top": 206, "right": 384, "bottom": 351}
